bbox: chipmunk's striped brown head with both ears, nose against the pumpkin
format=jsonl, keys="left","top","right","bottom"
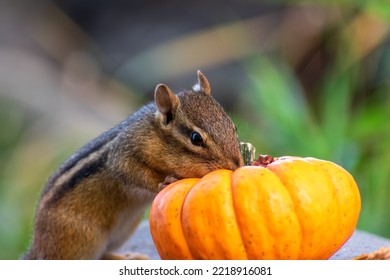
{"left": 155, "top": 71, "right": 243, "bottom": 178}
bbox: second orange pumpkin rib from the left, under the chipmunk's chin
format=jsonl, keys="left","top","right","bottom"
{"left": 182, "top": 169, "right": 245, "bottom": 259}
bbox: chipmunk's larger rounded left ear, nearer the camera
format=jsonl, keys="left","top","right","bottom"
{"left": 154, "top": 84, "right": 180, "bottom": 124}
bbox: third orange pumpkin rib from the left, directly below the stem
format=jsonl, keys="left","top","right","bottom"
{"left": 232, "top": 166, "right": 301, "bottom": 259}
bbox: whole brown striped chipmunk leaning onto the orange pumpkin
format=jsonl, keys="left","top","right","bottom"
{"left": 22, "top": 71, "right": 243, "bottom": 259}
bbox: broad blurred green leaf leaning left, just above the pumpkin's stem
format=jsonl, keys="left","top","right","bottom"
{"left": 241, "top": 56, "right": 327, "bottom": 156}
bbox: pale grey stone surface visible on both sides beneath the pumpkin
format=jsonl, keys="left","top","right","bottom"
{"left": 119, "top": 221, "right": 390, "bottom": 260}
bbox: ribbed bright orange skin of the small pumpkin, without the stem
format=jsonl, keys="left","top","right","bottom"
{"left": 149, "top": 156, "right": 361, "bottom": 260}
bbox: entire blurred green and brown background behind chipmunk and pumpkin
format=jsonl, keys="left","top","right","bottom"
{"left": 0, "top": 0, "right": 390, "bottom": 259}
